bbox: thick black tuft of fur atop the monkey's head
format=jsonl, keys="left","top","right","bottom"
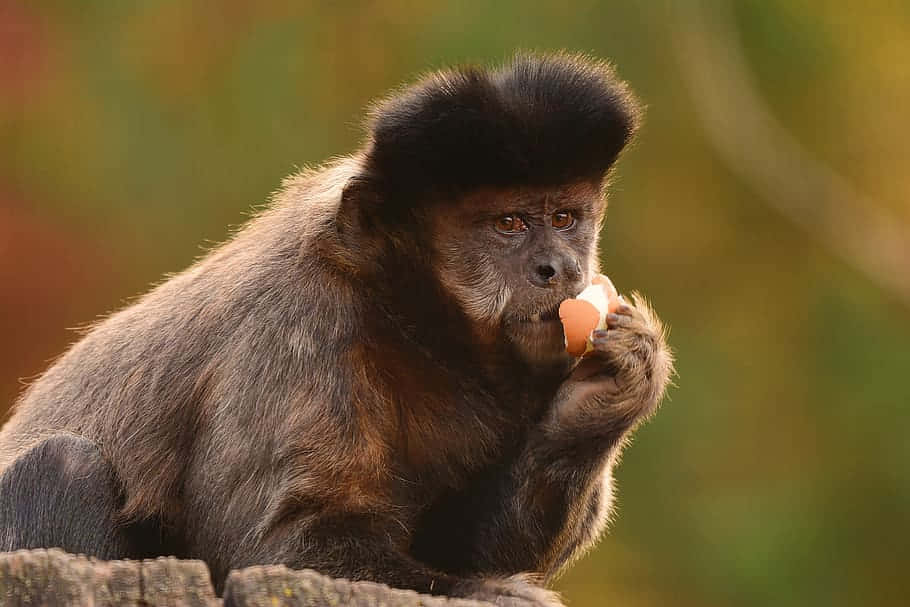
{"left": 367, "top": 54, "right": 638, "bottom": 200}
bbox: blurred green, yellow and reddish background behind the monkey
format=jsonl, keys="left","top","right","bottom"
{"left": 0, "top": 0, "right": 910, "bottom": 607}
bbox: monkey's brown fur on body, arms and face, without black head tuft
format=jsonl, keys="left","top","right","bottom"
{"left": 0, "top": 58, "right": 672, "bottom": 605}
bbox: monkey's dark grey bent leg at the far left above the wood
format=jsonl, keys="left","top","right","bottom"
{"left": 0, "top": 435, "right": 162, "bottom": 559}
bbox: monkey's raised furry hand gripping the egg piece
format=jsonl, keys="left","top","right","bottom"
{"left": 547, "top": 293, "right": 673, "bottom": 442}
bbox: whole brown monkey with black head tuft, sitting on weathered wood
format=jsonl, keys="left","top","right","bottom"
{"left": 0, "top": 52, "right": 673, "bottom": 607}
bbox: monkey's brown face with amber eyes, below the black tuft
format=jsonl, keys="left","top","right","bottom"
{"left": 431, "top": 182, "right": 604, "bottom": 365}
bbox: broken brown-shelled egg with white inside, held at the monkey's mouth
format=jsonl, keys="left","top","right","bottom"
{"left": 559, "top": 274, "right": 620, "bottom": 357}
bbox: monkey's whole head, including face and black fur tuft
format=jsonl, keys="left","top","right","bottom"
{"left": 334, "top": 54, "right": 638, "bottom": 364}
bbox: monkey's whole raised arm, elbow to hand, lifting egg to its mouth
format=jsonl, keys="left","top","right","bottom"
{"left": 414, "top": 297, "right": 672, "bottom": 576}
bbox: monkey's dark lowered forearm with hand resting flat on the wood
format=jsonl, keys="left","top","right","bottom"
{"left": 225, "top": 513, "right": 562, "bottom": 607}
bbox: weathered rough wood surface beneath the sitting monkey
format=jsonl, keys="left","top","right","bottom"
{"left": 0, "top": 549, "right": 498, "bottom": 607}
